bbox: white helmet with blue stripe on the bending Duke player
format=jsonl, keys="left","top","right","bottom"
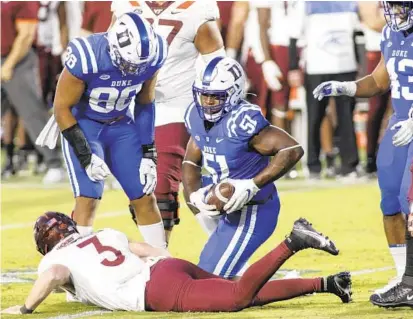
{"left": 108, "top": 12, "right": 158, "bottom": 75}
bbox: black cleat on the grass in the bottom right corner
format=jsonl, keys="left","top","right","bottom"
{"left": 370, "top": 282, "right": 413, "bottom": 308}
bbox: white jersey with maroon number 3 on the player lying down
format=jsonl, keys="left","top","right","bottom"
{"left": 38, "top": 229, "right": 164, "bottom": 311}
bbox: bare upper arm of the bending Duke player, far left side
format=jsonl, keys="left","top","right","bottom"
{"left": 53, "top": 68, "right": 85, "bottom": 131}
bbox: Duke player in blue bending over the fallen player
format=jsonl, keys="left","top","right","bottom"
{"left": 54, "top": 13, "right": 167, "bottom": 247}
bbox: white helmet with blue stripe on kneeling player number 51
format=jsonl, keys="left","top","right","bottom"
{"left": 192, "top": 57, "right": 245, "bottom": 122}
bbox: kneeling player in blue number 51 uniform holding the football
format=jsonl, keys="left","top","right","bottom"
{"left": 182, "top": 57, "right": 304, "bottom": 278}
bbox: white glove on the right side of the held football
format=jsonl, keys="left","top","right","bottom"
{"left": 224, "top": 179, "right": 260, "bottom": 214}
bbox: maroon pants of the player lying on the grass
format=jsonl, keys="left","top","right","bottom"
{"left": 145, "top": 242, "right": 322, "bottom": 312}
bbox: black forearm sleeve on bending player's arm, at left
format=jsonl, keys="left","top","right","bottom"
{"left": 62, "top": 123, "right": 92, "bottom": 169}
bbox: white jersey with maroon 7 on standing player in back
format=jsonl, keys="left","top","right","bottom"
{"left": 112, "top": 0, "right": 219, "bottom": 126}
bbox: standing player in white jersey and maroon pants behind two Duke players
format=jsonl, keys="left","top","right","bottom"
{"left": 112, "top": 0, "right": 225, "bottom": 239}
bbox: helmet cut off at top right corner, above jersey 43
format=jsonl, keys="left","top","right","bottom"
{"left": 383, "top": 1, "right": 413, "bottom": 32}
